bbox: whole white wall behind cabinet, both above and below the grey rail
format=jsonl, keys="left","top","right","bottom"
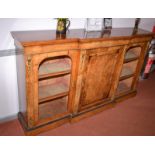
{"left": 0, "top": 18, "right": 155, "bottom": 120}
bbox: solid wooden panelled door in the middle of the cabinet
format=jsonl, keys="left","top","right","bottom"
{"left": 80, "top": 46, "right": 123, "bottom": 110}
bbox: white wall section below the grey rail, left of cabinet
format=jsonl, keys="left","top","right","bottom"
{"left": 0, "top": 56, "right": 18, "bottom": 120}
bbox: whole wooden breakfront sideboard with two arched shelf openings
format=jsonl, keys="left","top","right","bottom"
{"left": 12, "top": 28, "right": 153, "bottom": 135}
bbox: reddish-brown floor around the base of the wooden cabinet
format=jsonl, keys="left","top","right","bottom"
{"left": 0, "top": 73, "right": 155, "bottom": 136}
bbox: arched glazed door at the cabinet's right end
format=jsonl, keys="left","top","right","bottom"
{"left": 116, "top": 42, "right": 149, "bottom": 98}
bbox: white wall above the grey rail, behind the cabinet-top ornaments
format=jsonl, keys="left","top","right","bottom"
{"left": 0, "top": 18, "right": 155, "bottom": 50}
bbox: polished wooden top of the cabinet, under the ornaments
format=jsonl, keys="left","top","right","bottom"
{"left": 11, "top": 28, "right": 153, "bottom": 46}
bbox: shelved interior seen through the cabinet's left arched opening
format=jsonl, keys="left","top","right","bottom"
{"left": 38, "top": 56, "right": 71, "bottom": 119}
